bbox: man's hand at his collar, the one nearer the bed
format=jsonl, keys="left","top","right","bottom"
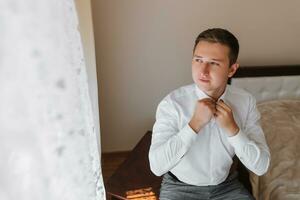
{"left": 215, "top": 100, "right": 240, "bottom": 136}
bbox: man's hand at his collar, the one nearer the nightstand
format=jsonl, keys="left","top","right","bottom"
{"left": 189, "top": 98, "right": 216, "bottom": 133}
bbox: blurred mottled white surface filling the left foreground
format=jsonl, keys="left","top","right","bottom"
{"left": 0, "top": 0, "right": 105, "bottom": 200}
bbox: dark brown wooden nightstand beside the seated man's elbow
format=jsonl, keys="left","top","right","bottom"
{"left": 105, "top": 131, "right": 162, "bottom": 199}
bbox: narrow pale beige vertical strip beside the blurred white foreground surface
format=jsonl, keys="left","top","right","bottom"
{"left": 75, "top": 0, "right": 100, "bottom": 150}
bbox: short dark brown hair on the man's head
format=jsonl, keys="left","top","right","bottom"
{"left": 193, "top": 28, "right": 239, "bottom": 66}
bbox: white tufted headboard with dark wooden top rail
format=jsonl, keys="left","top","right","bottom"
{"left": 229, "top": 65, "right": 300, "bottom": 102}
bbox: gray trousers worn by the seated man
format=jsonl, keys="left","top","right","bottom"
{"left": 159, "top": 172, "right": 254, "bottom": 200}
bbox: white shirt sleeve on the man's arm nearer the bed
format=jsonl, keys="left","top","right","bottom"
{"left": 228, "top": 97, "right": 270, "bottom": 176}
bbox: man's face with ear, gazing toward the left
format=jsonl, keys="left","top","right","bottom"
{"left": 192, "top": 41, "right": 238, "bottom": 99}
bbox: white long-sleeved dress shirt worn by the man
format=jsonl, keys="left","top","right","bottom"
{"left": 149, "top": 84, "right": 270, "bottom": 186}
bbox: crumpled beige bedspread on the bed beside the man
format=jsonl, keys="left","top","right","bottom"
{"left": 250, "top": 100, "right": 300, "bottom": 200}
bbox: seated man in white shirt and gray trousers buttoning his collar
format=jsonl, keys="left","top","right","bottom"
{"left": 149, "top": 28, "right": 270, "bottom": 200}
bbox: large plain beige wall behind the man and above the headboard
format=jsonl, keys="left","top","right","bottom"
{"left": 92, "top": 0, "right": 300, "bottom": 152}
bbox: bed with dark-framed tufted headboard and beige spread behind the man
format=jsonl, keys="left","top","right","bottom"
{"left": 230, "top": 65, "right": 300, "bottom": 200}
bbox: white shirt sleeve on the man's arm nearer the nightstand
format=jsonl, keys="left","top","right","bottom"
{"left": 149, "top": 98, "right": 197, "bottom": 176}
